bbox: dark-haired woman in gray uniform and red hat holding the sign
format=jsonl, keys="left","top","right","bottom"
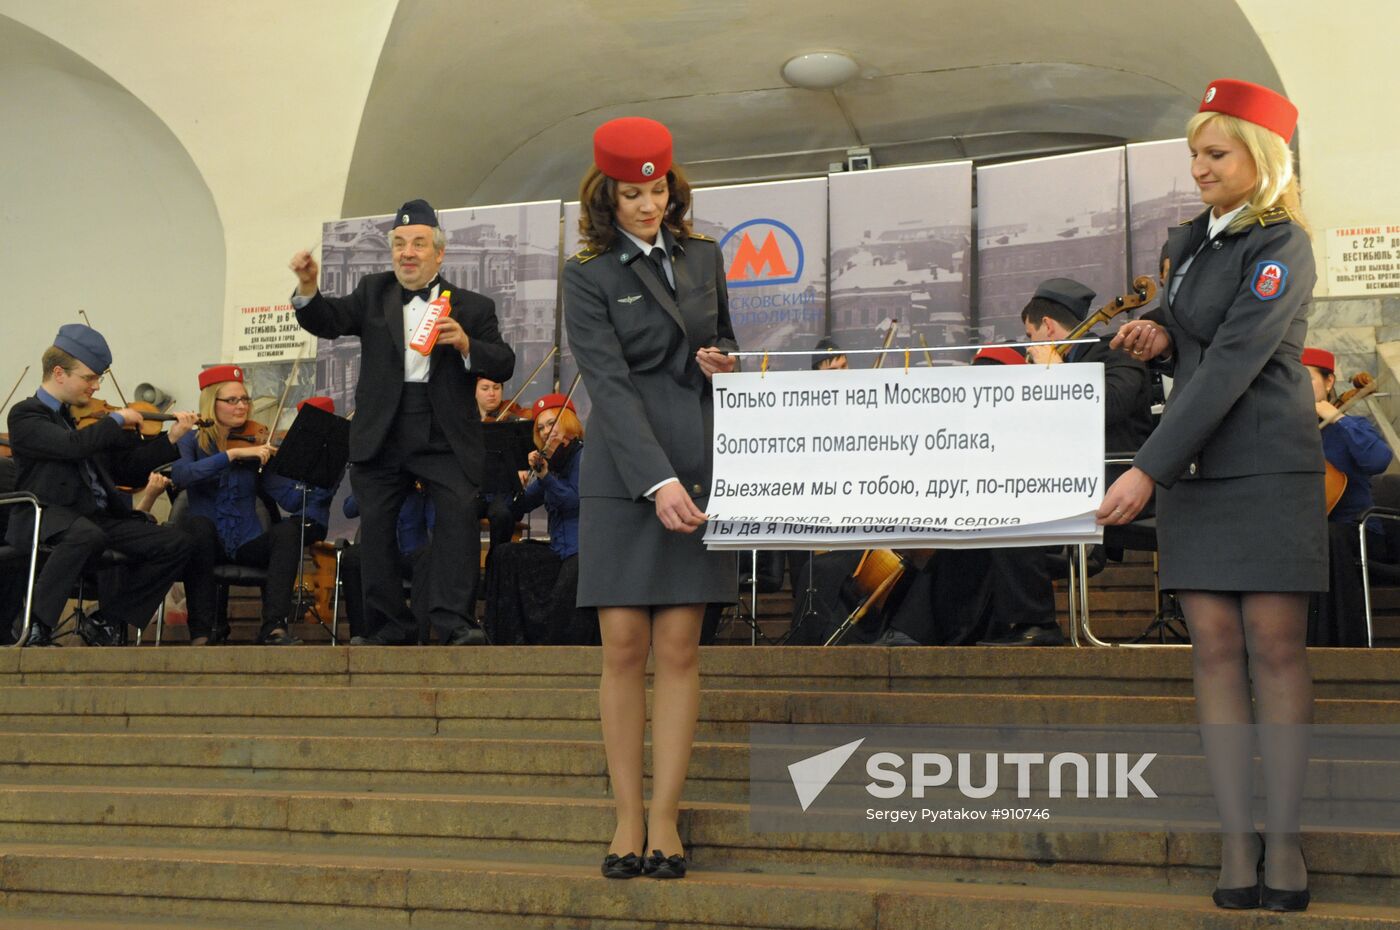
{"left": 564, "top": 118, "right": 738, "bottom": 878}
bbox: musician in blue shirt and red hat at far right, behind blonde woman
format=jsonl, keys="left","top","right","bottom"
{"left": 1302, "top": 347, "right": 1393, "bottom": 646}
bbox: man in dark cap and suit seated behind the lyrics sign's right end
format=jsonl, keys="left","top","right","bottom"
{"left": 979, "top": 277, "right": 1152, "bottom": 646}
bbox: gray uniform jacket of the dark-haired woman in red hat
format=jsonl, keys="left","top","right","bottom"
{"left": 564, "top": 230, "right": 738, "bottom": 500}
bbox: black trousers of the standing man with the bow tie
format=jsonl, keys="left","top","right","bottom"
{"left": 350, "top": 394, "right": 482, "bottom": 641}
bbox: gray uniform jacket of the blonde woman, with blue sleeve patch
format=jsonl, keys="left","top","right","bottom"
{"left": 1134, "top": 209, "right": 1323, "bottom": 487}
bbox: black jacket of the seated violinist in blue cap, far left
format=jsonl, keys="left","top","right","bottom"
{"left": 8, "top": 396, "right": 179, "bottom": 545}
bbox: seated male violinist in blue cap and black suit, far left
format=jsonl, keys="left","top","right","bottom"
{"left": 8, "top": 324, "right": 195, "bottom": 646}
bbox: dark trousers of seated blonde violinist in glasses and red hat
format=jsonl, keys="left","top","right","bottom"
{"left": 179, "top": 515, "right": 326, "bottom": 639}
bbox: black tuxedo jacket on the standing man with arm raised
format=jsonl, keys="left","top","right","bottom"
{"left": 297, "top": 272, "right": 515, "bottom": 485}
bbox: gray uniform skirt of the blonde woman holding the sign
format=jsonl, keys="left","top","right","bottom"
{"left": 1156, "top": 472, "right": 1327, "bottom": 592}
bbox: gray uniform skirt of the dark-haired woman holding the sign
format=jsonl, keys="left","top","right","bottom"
{"left": 578, "top": 497, "right": 739, "bottom": 606}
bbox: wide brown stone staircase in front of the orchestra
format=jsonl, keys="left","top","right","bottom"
{"left": 0, "top": 647, "right": 1400, "bottom": 930}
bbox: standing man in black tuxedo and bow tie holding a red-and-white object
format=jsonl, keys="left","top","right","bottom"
{"left": 291, "top": 200, "right": 515, "bottom": 646}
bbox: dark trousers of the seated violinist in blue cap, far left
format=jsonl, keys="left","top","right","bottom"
{"left": 34, "top": 514, "right": 189, "bottom": 629}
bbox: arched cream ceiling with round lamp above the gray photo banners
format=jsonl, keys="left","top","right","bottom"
{"left": 344, "top": 0, "right": 1281, "bottom": 216}
